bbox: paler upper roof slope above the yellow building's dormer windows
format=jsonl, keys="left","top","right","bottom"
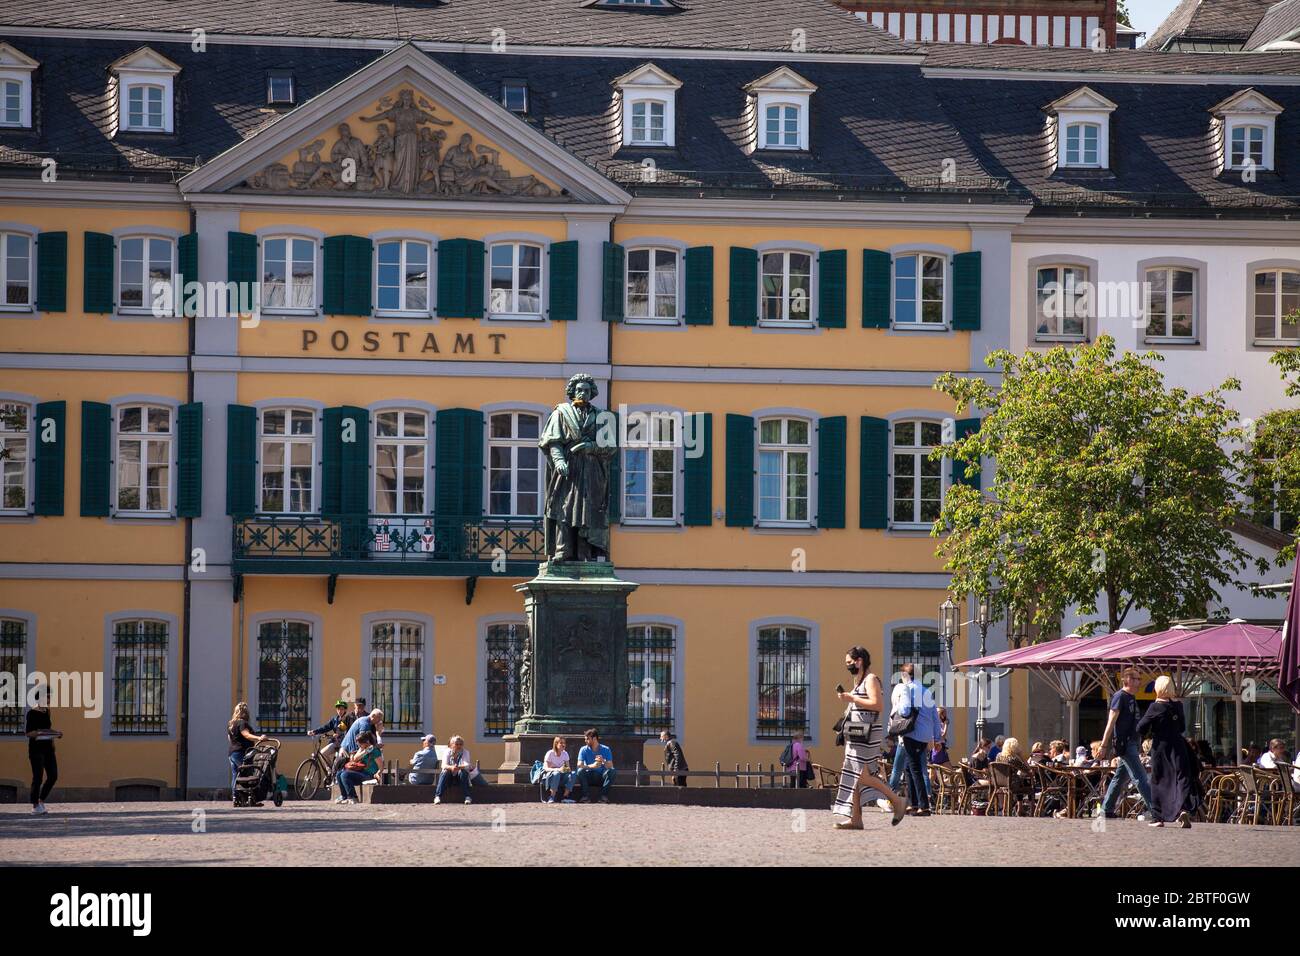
{"left": 0, "top": 0, "right": 910, "bottom": 53}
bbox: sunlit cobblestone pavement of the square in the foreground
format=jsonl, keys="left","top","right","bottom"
{"left": 0, "top": 803, "right": 1300, "bottom": 866}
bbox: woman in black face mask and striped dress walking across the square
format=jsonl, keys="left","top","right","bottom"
{"left": 831, "top": 648, "right": 905, "bottom": 830}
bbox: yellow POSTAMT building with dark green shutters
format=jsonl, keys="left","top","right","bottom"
{"left": 0, "top": 11, "right": 1027, "bottom": 797}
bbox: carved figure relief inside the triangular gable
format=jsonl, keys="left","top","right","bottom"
{"left": 244, "top": 90, "right": 559, "bottom": 199}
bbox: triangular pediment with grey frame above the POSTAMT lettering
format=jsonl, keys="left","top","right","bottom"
{"left": 181, "top": 44, "right": 629, "bottom": 203}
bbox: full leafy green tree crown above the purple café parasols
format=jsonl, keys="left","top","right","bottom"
{"left": 932, "top": 336, "right": 1249, "bottom": 632}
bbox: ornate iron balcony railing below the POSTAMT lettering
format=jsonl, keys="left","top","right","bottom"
{"left": 231, "top": 515, "right": 545, "bottom": 576}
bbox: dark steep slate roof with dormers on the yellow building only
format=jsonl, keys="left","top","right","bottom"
{"left": 0, "top": 38, "right": 1005, "bottom": 200}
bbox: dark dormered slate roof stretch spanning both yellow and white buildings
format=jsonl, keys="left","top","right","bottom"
{"left": 0, "top": 27, "right": 1300, "bottom": 215}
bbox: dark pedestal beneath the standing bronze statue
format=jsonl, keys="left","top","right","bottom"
{"left": 501, "top": 561, "right": 645, "bottom": 779}
